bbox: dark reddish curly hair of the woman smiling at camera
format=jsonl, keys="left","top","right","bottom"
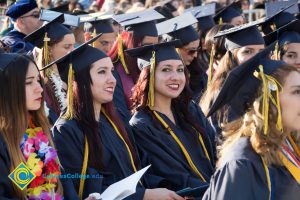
{"left": 132, "top": 63, "right": 206, "bottom": 138}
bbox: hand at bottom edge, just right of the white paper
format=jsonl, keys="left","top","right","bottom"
{"left": 143, "top": 188, "right": 184, "bottom": 200}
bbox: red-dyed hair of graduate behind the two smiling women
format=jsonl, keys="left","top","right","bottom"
{"left": 107, "top": 31, "right": 143, "bottom": 83}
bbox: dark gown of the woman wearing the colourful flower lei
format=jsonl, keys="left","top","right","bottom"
{"left": 0, "top": 135, "right": 79, "bottom": 200}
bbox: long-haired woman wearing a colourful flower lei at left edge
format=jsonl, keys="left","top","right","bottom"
{"left": 0, "top": 52, "right": 63, "bottom": 200}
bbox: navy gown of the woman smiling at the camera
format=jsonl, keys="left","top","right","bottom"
{"left": 129, "top": 103, "right": 215, "bottom": 191}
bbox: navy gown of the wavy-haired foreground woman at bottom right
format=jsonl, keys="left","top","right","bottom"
{"left": 203, "top": 137, "right": 300, "bottom": 200}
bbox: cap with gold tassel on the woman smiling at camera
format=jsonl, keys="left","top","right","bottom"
{"left": 125, "top": 40, "right": 181, "bottom": 109}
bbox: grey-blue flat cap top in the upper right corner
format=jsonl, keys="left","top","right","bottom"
{"left": 265, "top": 0, "right": 299, "bottom": 17}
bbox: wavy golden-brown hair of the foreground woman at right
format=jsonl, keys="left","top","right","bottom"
{"left": 218, "top": 65, "right": 300, "bottom": 166}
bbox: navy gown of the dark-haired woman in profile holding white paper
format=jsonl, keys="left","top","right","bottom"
{"left": 53, "top": 115, "right": 145, "bottom": 200}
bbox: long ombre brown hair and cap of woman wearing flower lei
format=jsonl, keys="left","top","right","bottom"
{"left": 0, "top": 55, "right": 62, "bottom": 199}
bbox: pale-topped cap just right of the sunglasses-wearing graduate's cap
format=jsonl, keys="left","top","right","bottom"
{"left": 185, "top": 3, "right": 216, "bottom": 32}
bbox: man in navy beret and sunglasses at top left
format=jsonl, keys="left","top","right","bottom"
{"left": 1, "top": 0, "right": 42, "bottom": 53}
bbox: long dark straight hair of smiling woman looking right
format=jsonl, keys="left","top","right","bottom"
{"left": 73, "top": 63, "right": 136, "bottom": 170}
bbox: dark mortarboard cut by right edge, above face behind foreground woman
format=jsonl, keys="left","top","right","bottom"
{"left": 264, "top": 20, "right": 300, "bottom": 46}
